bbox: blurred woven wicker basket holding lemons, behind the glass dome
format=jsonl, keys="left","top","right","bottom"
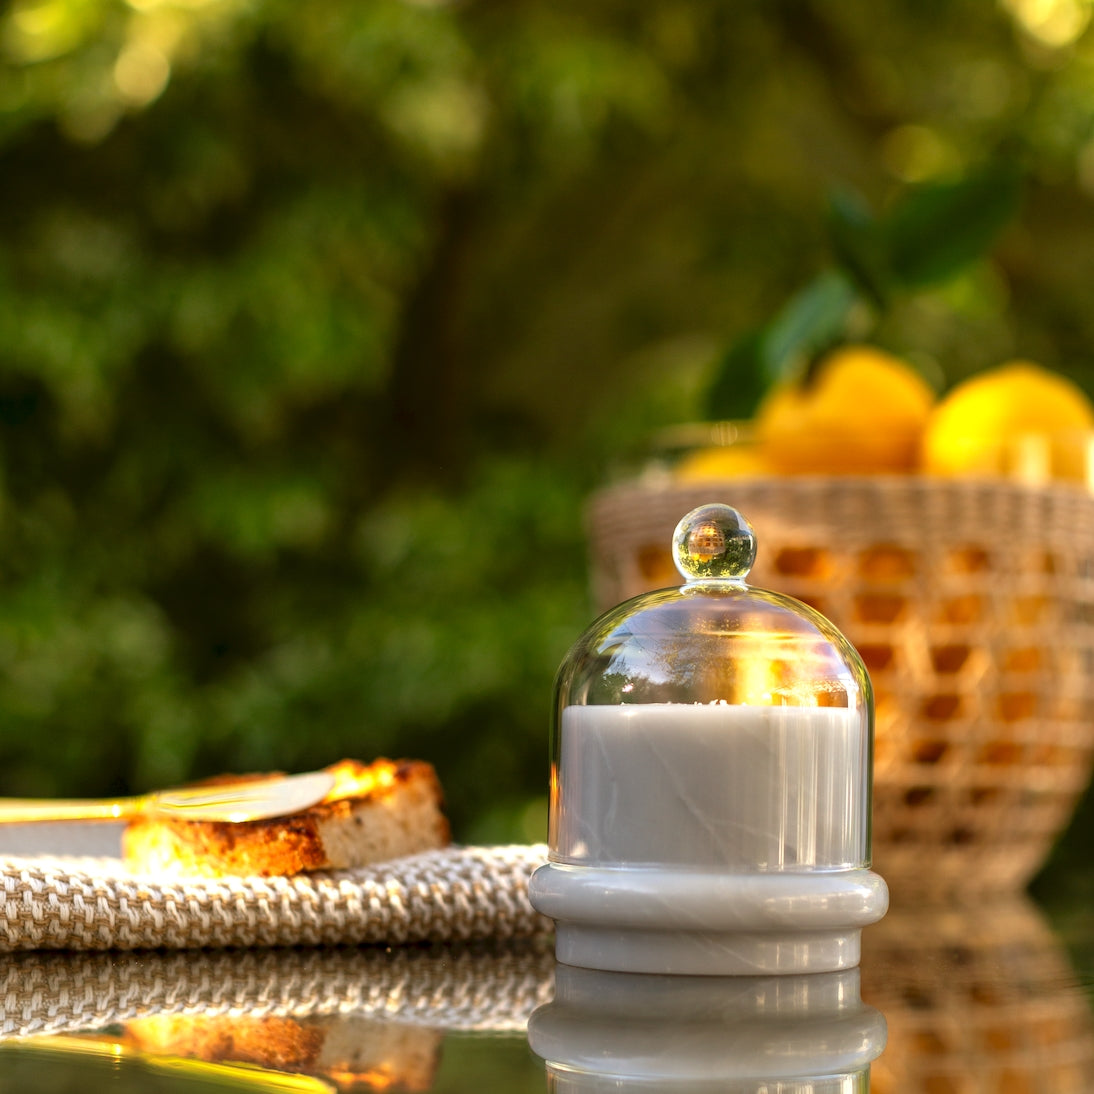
{"left": 589, "top": 476, "right": 1094, "bottom": 893}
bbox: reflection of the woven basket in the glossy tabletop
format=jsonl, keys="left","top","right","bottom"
{"left": 862, "top": 895, "right": 1094, "bottom": 1094}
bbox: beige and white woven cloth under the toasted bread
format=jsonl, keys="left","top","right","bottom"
{"left": 0, "top": 845, "right": 550, "bottom": 952}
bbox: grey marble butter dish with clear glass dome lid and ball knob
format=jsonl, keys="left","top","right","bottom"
{"left": 529, "top": 504, "right": 888, "bottom": 975}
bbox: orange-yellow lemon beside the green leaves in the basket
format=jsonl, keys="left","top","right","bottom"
{"left": 756, "top": 346, "right": 934, "bottom": 475}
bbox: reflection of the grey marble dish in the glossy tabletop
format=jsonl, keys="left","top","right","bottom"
{"left": 528, "top": 965, "right": 886, "bottom": 1094}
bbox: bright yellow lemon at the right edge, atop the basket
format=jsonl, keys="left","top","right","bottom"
{"left": 922, "top": 361, "right": 1094, "bottom": 481}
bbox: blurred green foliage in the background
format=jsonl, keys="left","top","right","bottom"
{"left": 0, "top": 0, "right": 1094, "bottom": 862}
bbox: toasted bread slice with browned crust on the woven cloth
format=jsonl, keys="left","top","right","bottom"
{"left": 121, "top": 759, "right": 451, "bottom": 877}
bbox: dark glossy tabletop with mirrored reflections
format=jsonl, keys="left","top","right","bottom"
{"left": 0, "top": 862, "right": 1094, "bottom": 1094}
